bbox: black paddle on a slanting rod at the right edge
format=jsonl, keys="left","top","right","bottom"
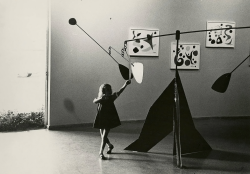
{"left": 212, "top": 55, "right": 250, "bottom": 93}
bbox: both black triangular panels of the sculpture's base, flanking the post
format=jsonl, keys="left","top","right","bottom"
{"left": 125, "top": 71, "right": 211, "bottom": 155}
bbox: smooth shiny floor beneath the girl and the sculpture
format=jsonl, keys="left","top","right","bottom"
{"left": 0, "top": 118, "right": 250, "bottom": 174}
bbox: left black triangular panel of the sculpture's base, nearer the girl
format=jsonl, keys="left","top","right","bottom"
{"left": 125, "top": 80, "right": 174, "bottom": 152}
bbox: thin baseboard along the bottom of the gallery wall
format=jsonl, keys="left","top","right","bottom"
{"left": 46, "top": 116, "right": 250, "bottom": 130}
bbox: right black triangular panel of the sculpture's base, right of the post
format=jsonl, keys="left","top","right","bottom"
{"left": 174, "top": 72, "right": 212, "bottom": 155}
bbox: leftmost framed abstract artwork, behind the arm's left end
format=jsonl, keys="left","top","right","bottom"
{"left": 128, "top": 29, "right": 159, "bottom": 56}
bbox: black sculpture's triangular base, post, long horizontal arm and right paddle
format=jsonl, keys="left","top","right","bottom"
{"left": 124, "top": 27, "right": 250, "bottom": 168}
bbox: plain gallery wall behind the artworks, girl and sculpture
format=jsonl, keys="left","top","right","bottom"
{"left": 49, "top": 0, "right": 250, "bottom": 126}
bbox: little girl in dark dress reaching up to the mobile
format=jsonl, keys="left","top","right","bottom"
{"left": 93, "top": 80, "right": 131, "bottom": 160}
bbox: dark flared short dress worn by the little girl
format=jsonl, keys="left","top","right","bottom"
{"left": 93, "top": 93, "right": 121, "bottom": 129}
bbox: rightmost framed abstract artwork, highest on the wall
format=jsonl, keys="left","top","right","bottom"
{"left": 206, "top": 21, "right": 235, "bottom": 47}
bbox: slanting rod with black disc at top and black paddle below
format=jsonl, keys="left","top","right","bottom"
{"left": 69, "top": 18, "right": 133, "bottom": 80}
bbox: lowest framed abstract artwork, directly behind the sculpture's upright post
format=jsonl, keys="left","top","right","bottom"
{"left": 171, "top": 42, "right": 200, "bottom": 69}
